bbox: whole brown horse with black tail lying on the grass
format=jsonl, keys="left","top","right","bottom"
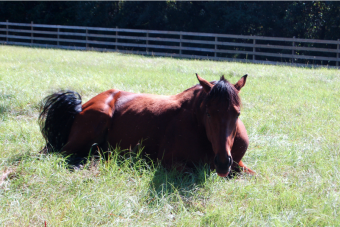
{"left": 39, "top": 74, "right": 254, "bottom": 177}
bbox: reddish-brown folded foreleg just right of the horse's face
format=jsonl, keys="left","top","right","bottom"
{"left": 231, "top": 120, "right": 256, "bottom": 175}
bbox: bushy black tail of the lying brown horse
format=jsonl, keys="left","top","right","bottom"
{"left": 38, "top": 91, "right": 82, "bottom": 152}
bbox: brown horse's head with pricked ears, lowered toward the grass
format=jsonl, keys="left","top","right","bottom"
{"left": 196, "top": 74, "right": 247, "bottom": 177}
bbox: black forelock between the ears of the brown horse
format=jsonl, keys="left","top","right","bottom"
{"left": 207, "top": 76, "right": 241, "bottom": 106}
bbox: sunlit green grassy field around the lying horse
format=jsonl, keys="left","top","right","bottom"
{"left": 0, "top": 46, "right": 340, "bottom": 226}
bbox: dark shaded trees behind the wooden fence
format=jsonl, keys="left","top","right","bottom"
{"left": 0, "top": 0, "right": 340, "bottom": 40}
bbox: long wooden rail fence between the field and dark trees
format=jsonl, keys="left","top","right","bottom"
{"left": 0, "top": 21, "right": 340, "bottom": 67}
